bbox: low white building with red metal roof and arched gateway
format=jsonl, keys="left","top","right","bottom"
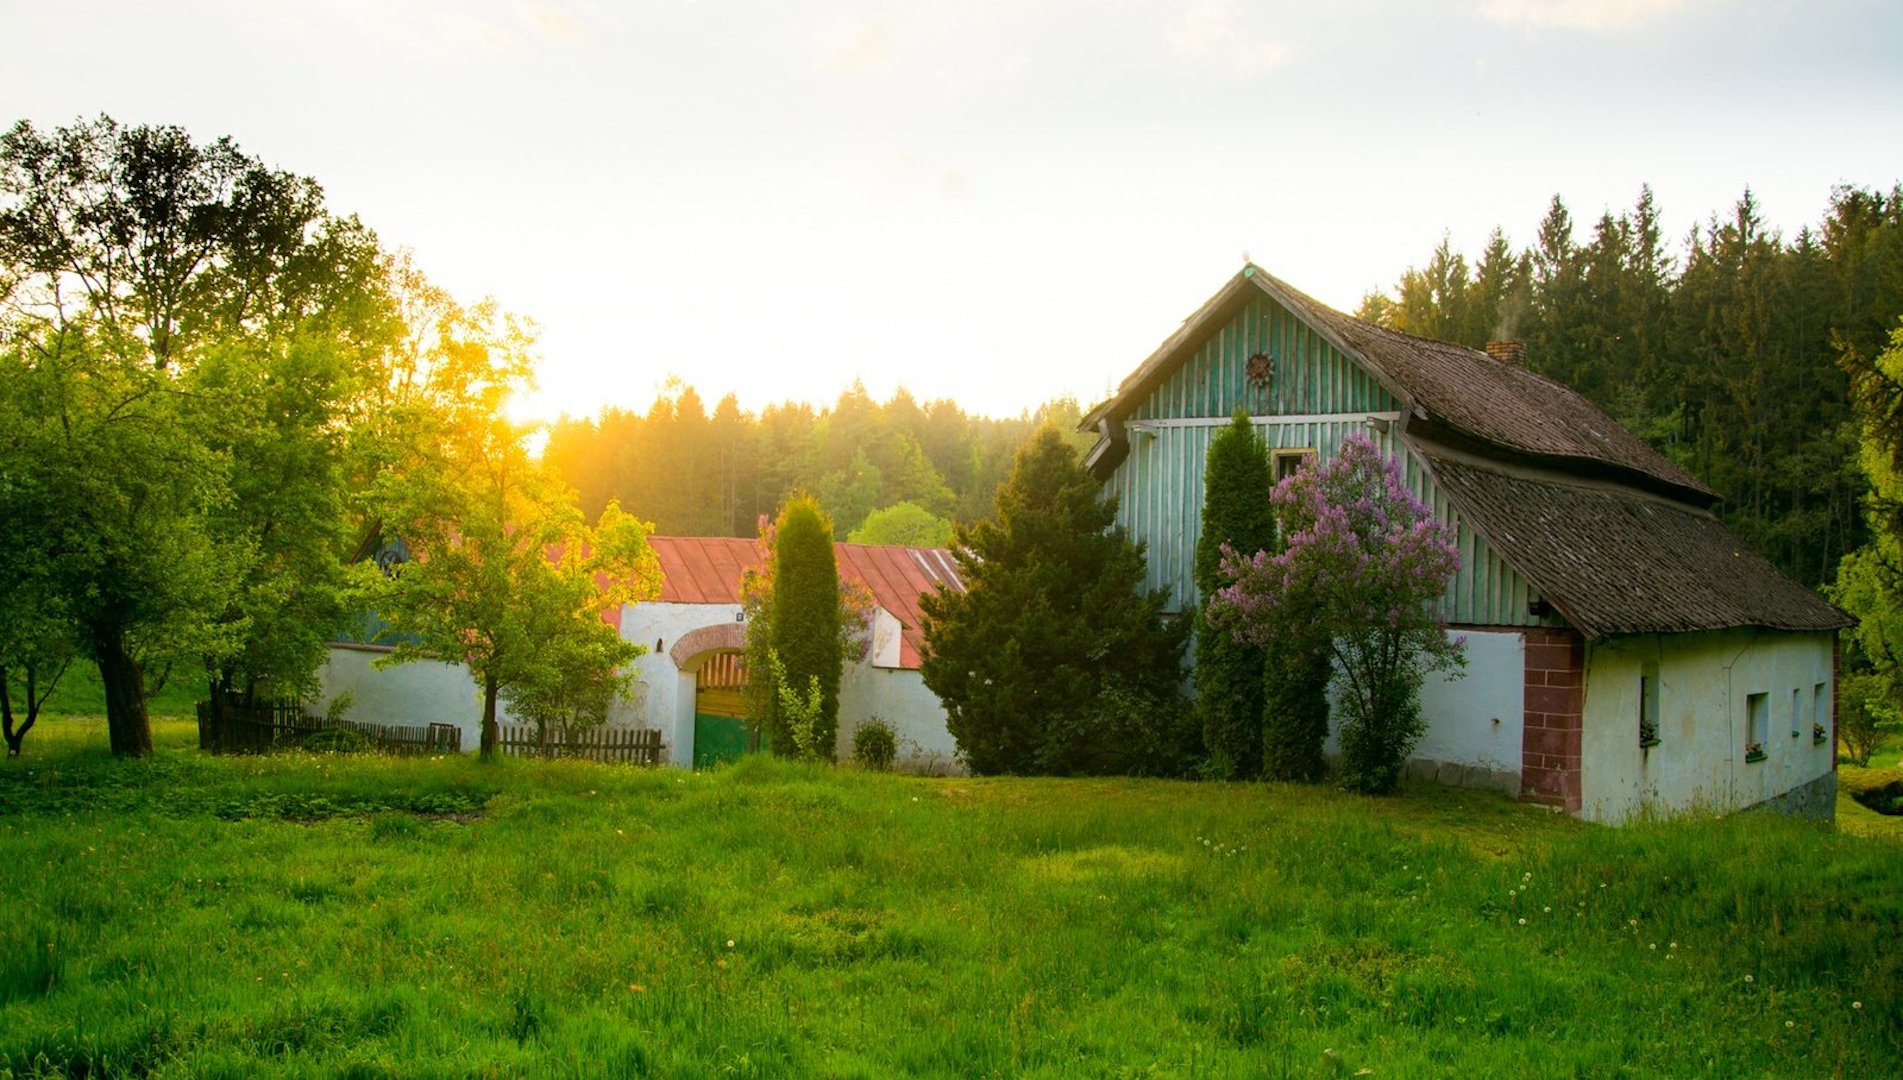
{"left": 620, "top": 536, "right": 965, "bottom": 770}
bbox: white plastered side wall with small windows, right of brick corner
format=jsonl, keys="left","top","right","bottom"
{"left": 1579, "top": 629, "right": 1834, "bottom": 823}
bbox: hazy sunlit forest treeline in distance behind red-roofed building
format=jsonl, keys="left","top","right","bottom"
{"left": 542, "top": 382, "right": 1089, "bottom": 540}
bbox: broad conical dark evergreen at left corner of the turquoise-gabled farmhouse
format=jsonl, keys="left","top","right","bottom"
{"left": 919, "top": 426, "right": 1195, "bottom": 774}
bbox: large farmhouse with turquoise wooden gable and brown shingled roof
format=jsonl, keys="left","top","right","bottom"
{"left": 1085, "top": 264, "right": 1852, "bottom": 821}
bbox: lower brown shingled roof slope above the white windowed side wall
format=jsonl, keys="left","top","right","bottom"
{"left": 1414, "top": 445, "right": 1855, "bottom": 637}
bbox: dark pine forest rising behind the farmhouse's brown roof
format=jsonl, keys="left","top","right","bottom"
{"left": 1361, "top": 186, "right": 1903, "bottom": 586}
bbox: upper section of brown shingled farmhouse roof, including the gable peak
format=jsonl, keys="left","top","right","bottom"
{"left": 1085, "top": 264, "right": 1717, "bottom": 504}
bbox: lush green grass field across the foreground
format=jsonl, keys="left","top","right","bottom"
{"left": 0, "top": 719, "right": 1903, "bottom": 1078}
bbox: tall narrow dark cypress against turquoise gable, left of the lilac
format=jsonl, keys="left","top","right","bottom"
{"left": 1195, "top": 411, "right": 1277, "bottom": 780}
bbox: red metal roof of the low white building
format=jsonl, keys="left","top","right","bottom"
{"left": 647, "top": 536, "right": 965, "bottom": 669}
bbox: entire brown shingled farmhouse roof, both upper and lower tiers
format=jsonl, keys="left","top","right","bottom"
{"left": 1083, "top": 264, "right": 1855, "bottom": 637}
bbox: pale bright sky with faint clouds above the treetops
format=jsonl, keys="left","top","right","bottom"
{"left": 0, "top": 0, "right": 1903, "bottom": 418}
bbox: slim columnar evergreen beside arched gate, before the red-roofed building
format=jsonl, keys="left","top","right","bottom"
{"left": 754, "top": 494, "right": 845, "bottom": 761}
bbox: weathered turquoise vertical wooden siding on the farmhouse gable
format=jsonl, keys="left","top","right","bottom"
{"left": 1106, "top": 297, "right": 1540, "bottom": 626}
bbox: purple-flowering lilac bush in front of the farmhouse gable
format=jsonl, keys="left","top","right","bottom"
{"left": 1208, "top": 434, "right": 1463, "bottom": 793}
